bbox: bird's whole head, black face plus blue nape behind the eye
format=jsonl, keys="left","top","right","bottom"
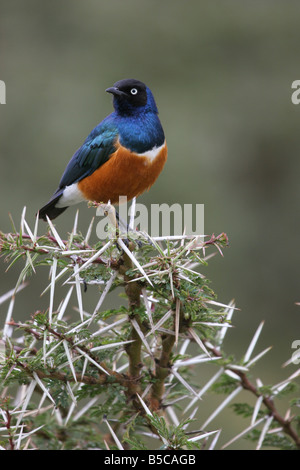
{"left": 105, "top": 78, "right": 158, "bottom": 115}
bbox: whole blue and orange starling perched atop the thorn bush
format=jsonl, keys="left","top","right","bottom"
{"left": 39, "top": 79, "right": 168, "bottom": 221}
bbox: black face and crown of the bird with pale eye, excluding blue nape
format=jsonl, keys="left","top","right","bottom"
{"left": 105, "top": 78, "right": 150, "bottom": 109}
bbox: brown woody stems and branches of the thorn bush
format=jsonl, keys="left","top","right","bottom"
{"left": 0, "top": 220, "right": 300, "bottom": 449}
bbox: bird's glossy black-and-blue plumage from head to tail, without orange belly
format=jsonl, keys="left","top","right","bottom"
{"left": 40, "top": 79, "right": 165, "bottom": 219}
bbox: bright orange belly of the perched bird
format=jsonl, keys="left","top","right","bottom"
{"left": 78, "top": 144, "right": 168, "bottom": 204}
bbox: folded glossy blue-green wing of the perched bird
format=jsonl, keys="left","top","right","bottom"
{"left": 58, "top": 127, "right": 118, "bottom": 190}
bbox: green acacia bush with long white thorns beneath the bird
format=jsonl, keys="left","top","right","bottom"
{"left": 0, "top": 210, "right": 300, "bottom": 450}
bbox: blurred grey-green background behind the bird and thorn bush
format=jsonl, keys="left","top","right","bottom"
{"left": 0, "top": 0, "right": 300, "bottom": 448}
